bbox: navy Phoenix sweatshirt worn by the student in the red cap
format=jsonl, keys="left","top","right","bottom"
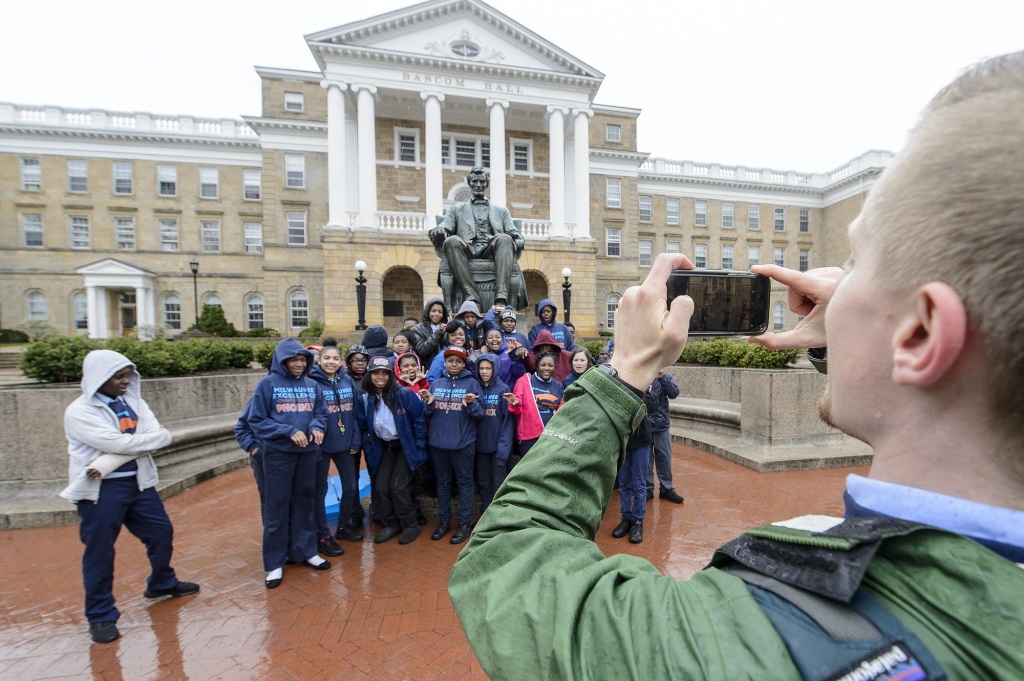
{"left": 424, "top": 368, "right": 483, "bottom": 451}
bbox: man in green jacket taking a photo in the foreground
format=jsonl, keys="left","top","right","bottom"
{"left": 449, "top": 52, "right": 1024, "bottom": 679}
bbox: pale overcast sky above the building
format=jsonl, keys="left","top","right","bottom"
{"left": 0, "top": 0, "right": 1024, "bottom": 172}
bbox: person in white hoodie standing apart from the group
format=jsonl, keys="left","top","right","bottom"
{"left": 60, "top": 350, "right": 199, "bottom": 643}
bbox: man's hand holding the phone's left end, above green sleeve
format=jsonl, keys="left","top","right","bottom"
{"left": 608, "top": 253, "right": 693, "bottom": 390}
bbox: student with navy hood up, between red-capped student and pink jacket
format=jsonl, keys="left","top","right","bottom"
{"left": 476, "top": 352, "right": 519, "bottom": 513}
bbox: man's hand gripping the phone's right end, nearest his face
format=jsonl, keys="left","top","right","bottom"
{"left": 750, "top": 265, "right": 843, "bottom": 350}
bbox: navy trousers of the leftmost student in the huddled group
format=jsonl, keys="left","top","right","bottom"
{"left": 263, "top": 448, "right": 319, "bottom": 572}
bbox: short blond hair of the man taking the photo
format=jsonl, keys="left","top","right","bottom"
{"left": 864, "top": 52, "right": 1024, "bottom": 433}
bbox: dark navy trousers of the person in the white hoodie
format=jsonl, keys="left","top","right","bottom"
{"left": 78, "top": 476, "right": 178, "bottom": 623}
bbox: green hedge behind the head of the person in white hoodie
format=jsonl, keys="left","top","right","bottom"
{"left": 20, "top": 336, "right": 253, "bottom": 383}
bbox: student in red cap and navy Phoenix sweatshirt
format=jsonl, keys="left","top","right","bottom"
{"left": 420, "top": 345, "right": 483, "bottom": 544}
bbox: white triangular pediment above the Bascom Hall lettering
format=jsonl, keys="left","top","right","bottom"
{"left": 306, "top": 0, "right": 604, "bottom": 81}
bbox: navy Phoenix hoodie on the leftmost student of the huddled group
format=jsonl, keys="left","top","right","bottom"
{"left": 249, "top": 338, "right": 327, "bottom": 454}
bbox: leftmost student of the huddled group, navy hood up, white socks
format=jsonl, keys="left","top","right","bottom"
{"left": 243, "top": 338, "right": 331, "bottom": 589}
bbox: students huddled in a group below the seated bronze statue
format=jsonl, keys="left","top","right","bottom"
{"left": 234, "top": 299, "right": 610, "bottom": 589}
